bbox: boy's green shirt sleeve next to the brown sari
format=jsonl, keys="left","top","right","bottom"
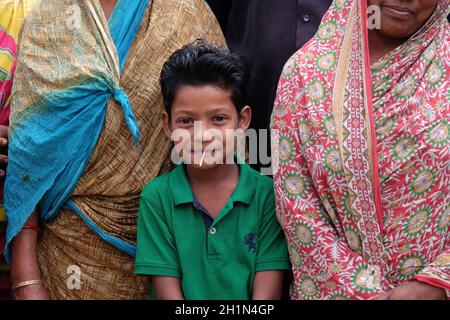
{"left": 135, "top": 196, "right": 181, "bottom": 277}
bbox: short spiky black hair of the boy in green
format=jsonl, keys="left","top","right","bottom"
{"left": 160, "top": 40, "right": 248, "bottom": 117}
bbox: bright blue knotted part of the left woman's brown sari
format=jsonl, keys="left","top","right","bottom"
{"left": 5, "top": 0, "right": 150, "bottom": 261}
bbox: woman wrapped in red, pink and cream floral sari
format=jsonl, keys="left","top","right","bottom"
{"left": 272, "top": 0, "right": 450, "bottom": 299}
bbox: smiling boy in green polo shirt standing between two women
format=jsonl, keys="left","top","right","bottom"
{"left": 135, "top": 41, "right": 290, "bottom": 300}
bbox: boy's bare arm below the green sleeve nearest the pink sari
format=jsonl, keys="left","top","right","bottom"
{"left": 253, "top": 270, "right": 284, "bottom": 300}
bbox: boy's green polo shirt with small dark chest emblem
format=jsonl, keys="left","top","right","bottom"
{"left": 135, "top": 164, "right": 290, "bottom": 300}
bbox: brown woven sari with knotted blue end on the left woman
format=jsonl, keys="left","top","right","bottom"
{"left": 5, "top": 0, "right": 225, "bottom": 299}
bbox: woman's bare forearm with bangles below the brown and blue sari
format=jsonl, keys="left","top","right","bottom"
{"left": 11, "top": 211, "right": 48, "bottom": 300}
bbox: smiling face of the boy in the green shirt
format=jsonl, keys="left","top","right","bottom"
{"left": 163, "top": 85, "right": 251, "bottom": 170}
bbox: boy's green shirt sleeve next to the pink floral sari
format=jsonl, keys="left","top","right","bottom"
{"left": 255, "top": 191, "right": 291, "bottom": 272}
